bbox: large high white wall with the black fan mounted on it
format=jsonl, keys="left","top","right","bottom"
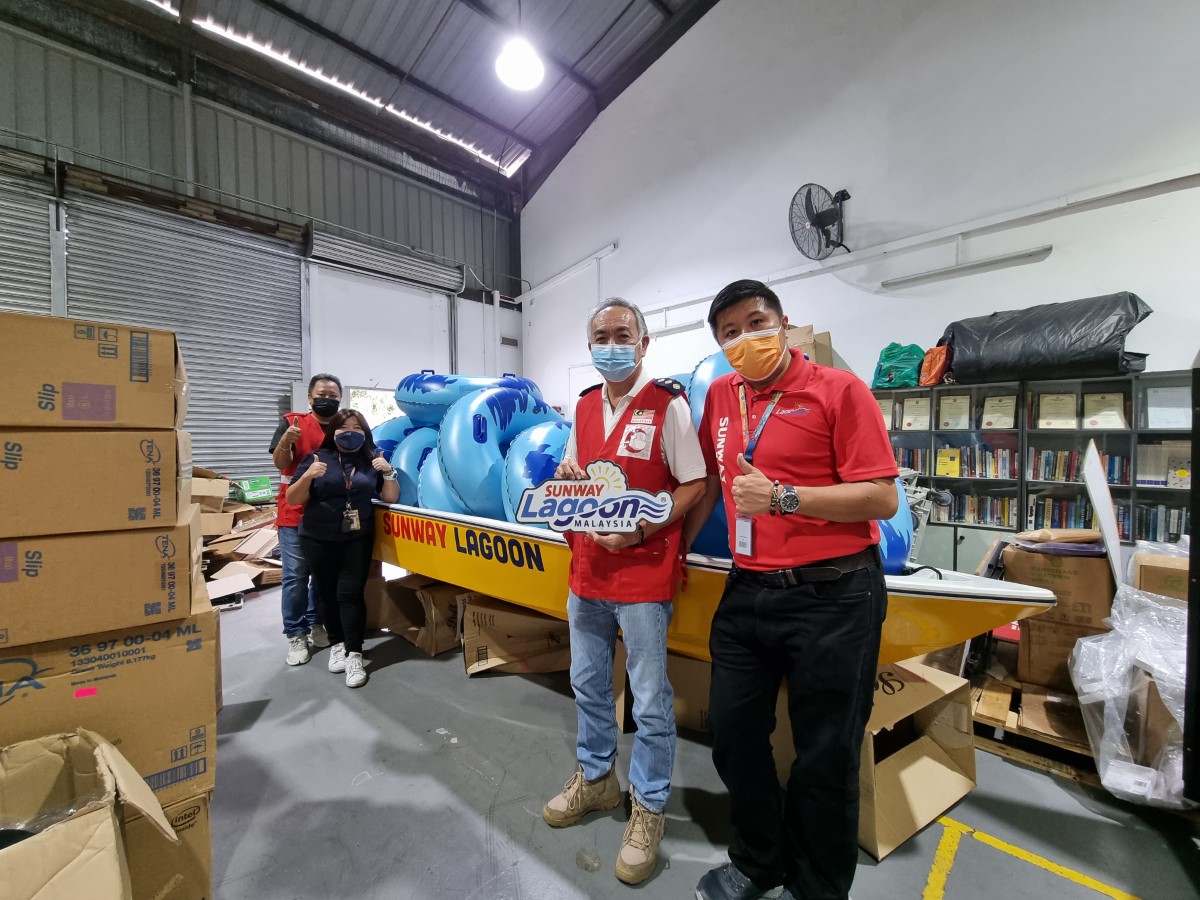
{"left": 522, "top": 0, "right": 1200, "bottom": 396}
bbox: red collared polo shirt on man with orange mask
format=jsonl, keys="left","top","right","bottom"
{"left": 700, "top": 350, "right": 899, "bottom": 571}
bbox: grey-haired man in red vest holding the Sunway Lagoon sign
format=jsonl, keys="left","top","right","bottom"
{"left": 541, "top": 298, "right": 706, "bottom": 884}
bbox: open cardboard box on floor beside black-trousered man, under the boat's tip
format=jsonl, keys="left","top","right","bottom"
{"left": 772, "top": 664, "right": 976, "bottom": 859}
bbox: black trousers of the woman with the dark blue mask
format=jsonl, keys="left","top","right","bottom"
{"left": 300, "top": 534, "right": 374, "bottom": 653}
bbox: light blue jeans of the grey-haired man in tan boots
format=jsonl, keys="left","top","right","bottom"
{"left": 566, "top": 593, "right": 676, "bottom": 812}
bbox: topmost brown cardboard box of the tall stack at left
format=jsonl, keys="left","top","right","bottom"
{"left": 0, "top": 312, "right": 187, "bottom": 428}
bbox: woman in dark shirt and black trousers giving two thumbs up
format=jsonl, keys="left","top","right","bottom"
{"left": 287, "top": 409, "right": 400, "bottom": 688}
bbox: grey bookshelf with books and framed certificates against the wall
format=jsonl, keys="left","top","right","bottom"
{"left": 874, "top": 371, "right": 1192, "bottom": 569}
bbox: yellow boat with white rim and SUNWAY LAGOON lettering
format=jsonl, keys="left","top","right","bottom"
{"left": 376, "top": 504, "right": 1055, "bottom": 665}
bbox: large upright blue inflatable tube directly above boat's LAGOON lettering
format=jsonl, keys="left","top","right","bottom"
{"left": 441, "top": 388, "right": 563, "bottom": 521}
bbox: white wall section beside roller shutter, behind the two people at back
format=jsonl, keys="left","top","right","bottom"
{"left": 308, "top": 265, "right": 450, "bottom": 389}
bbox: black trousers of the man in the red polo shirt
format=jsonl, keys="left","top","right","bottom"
{"left": 709, "top": 565, "right": 888, "bottom": 900}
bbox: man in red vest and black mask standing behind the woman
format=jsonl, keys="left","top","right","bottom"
{"left": 271, "top": 373, "right": 342, "bottom": 666}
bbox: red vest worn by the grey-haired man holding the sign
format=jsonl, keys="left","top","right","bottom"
{"left": 566, "top": 382, "right": 683, "bottom": 602}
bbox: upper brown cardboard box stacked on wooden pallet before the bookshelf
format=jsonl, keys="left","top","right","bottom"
{"left": 1004, "top": 547, "right": 1116, "bottom": 628}
